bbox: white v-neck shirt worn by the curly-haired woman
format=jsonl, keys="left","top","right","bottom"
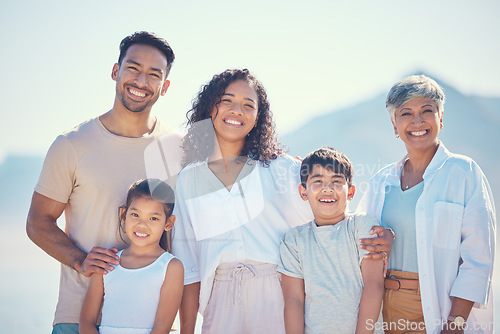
{"left": 173, "top": 156, "right": 313, "bottom": 314}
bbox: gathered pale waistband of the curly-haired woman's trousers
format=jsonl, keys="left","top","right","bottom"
{"left": 215, "top": 260, "right": 278, "bottom": 281}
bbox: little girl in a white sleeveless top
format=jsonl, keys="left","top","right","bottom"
{"left": 79, "top": 179, "right": 184, "bottom": 334}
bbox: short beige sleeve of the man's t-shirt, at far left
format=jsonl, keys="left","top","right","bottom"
{"left": 35, "top": 135, "right": 77, "bottom": 203}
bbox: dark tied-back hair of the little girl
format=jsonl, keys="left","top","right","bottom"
{"left": 120, "top": 179, "right": 175, "bottom": 252}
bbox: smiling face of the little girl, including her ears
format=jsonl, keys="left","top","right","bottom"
{"left": 121, "top": 197, "right": 175, "bottom": 246}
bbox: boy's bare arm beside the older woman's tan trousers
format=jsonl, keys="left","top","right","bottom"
{"left": 356, "top": 259, "right": 384, "bottom": 334}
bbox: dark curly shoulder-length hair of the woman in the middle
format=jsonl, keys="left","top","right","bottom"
{"left": 182, "top": 69, "right": 283, "bottom": 166}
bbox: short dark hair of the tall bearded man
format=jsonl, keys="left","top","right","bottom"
{"left": 118, "top": 31, "right": 175, "bottom": 78}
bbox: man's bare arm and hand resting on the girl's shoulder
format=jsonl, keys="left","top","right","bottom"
{"left": 26, "top": 192, "right": 119, "bottom": 277}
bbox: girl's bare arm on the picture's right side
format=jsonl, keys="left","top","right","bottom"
{"left": 151, "top": 258, "right": 184, "bottom": 334}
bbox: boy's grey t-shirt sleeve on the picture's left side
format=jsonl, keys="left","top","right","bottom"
{"left": 278, "top": 230, "right": 304, "bottom": 279}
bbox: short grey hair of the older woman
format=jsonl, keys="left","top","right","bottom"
{"left": 385, "top": 75, "right": 445, "bottom": 121}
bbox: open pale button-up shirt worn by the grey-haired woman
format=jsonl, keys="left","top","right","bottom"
{"left": 357, "top": 143, "right": 496, "bottom": 333}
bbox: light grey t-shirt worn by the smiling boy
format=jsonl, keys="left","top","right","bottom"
{"left": 278, "top": 214, "right": 379, "bottom": 333}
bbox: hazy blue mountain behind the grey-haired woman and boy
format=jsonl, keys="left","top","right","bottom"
{"left": 280, "top": 73, "right": 500, "bottom": 208}
